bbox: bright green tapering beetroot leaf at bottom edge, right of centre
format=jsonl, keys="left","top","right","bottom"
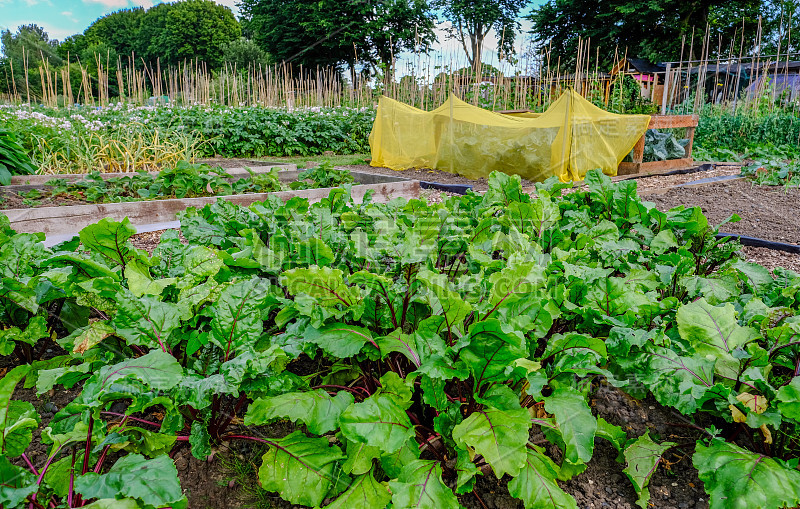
{"left": 508, "top": 448, "right": 578, "bottom": 509}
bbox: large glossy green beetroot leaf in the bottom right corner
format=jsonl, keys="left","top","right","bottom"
{"left": 692, "top": 439, "right": 800, "bottom": 509}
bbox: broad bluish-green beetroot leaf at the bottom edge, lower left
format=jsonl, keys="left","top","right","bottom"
{"left": 75, "top": 454, "right": 186, "bottom": 507}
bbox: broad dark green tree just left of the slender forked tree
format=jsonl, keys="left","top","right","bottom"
{"left": 239, "top": 0, "right": 435, "bottom": 74}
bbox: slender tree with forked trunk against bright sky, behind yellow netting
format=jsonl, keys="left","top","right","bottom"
{"left": 437, "top": 0, "right": 528, "bottom": 69}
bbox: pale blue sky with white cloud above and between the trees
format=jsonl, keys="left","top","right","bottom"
{"left": 0, "top": 0, "right": 545, "bottom": 72}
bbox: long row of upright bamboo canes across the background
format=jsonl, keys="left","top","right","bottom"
{"left": 4, "top": 20, "right": 800, "bottom": 113}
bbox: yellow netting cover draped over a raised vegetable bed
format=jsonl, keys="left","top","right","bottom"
{"left": 369, "top": 90, "right": 650, "bottom": 182}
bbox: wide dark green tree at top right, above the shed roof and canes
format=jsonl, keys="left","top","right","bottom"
{"left": 529, "top": 0, "right": 763, "bottom": 67}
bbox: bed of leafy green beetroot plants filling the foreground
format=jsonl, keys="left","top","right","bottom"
{"left": 0, "top": 172, "right": 800, "bottom": 509}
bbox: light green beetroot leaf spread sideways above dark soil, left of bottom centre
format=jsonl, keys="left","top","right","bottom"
{"left": 244, "top": 389, "right": 354, "bottom": 435}
